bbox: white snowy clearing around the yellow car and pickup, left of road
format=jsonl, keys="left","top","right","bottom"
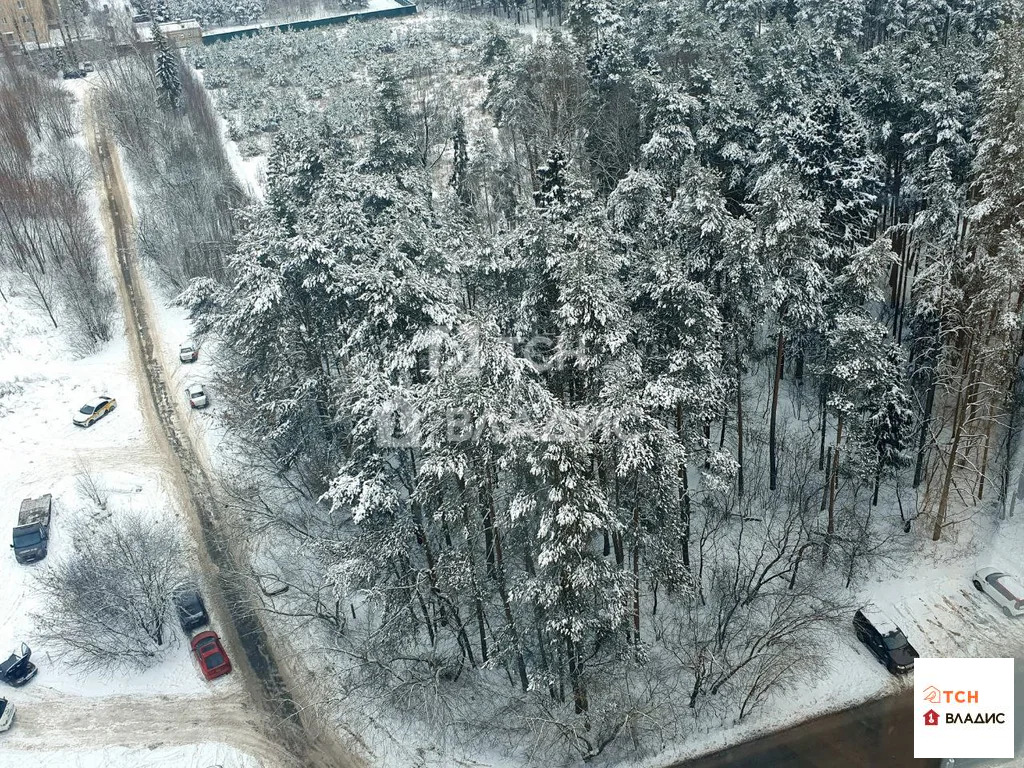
{"left": 0, "top": 298, "right": 208, "bottom": 700}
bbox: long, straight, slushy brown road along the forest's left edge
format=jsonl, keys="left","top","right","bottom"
{"left": 86, "top": 94, "right": 361, "bottom": 768}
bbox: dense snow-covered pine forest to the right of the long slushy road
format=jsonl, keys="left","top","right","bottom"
{"left": 90, "top": 0, "right": 1024, "bottom": 763}
